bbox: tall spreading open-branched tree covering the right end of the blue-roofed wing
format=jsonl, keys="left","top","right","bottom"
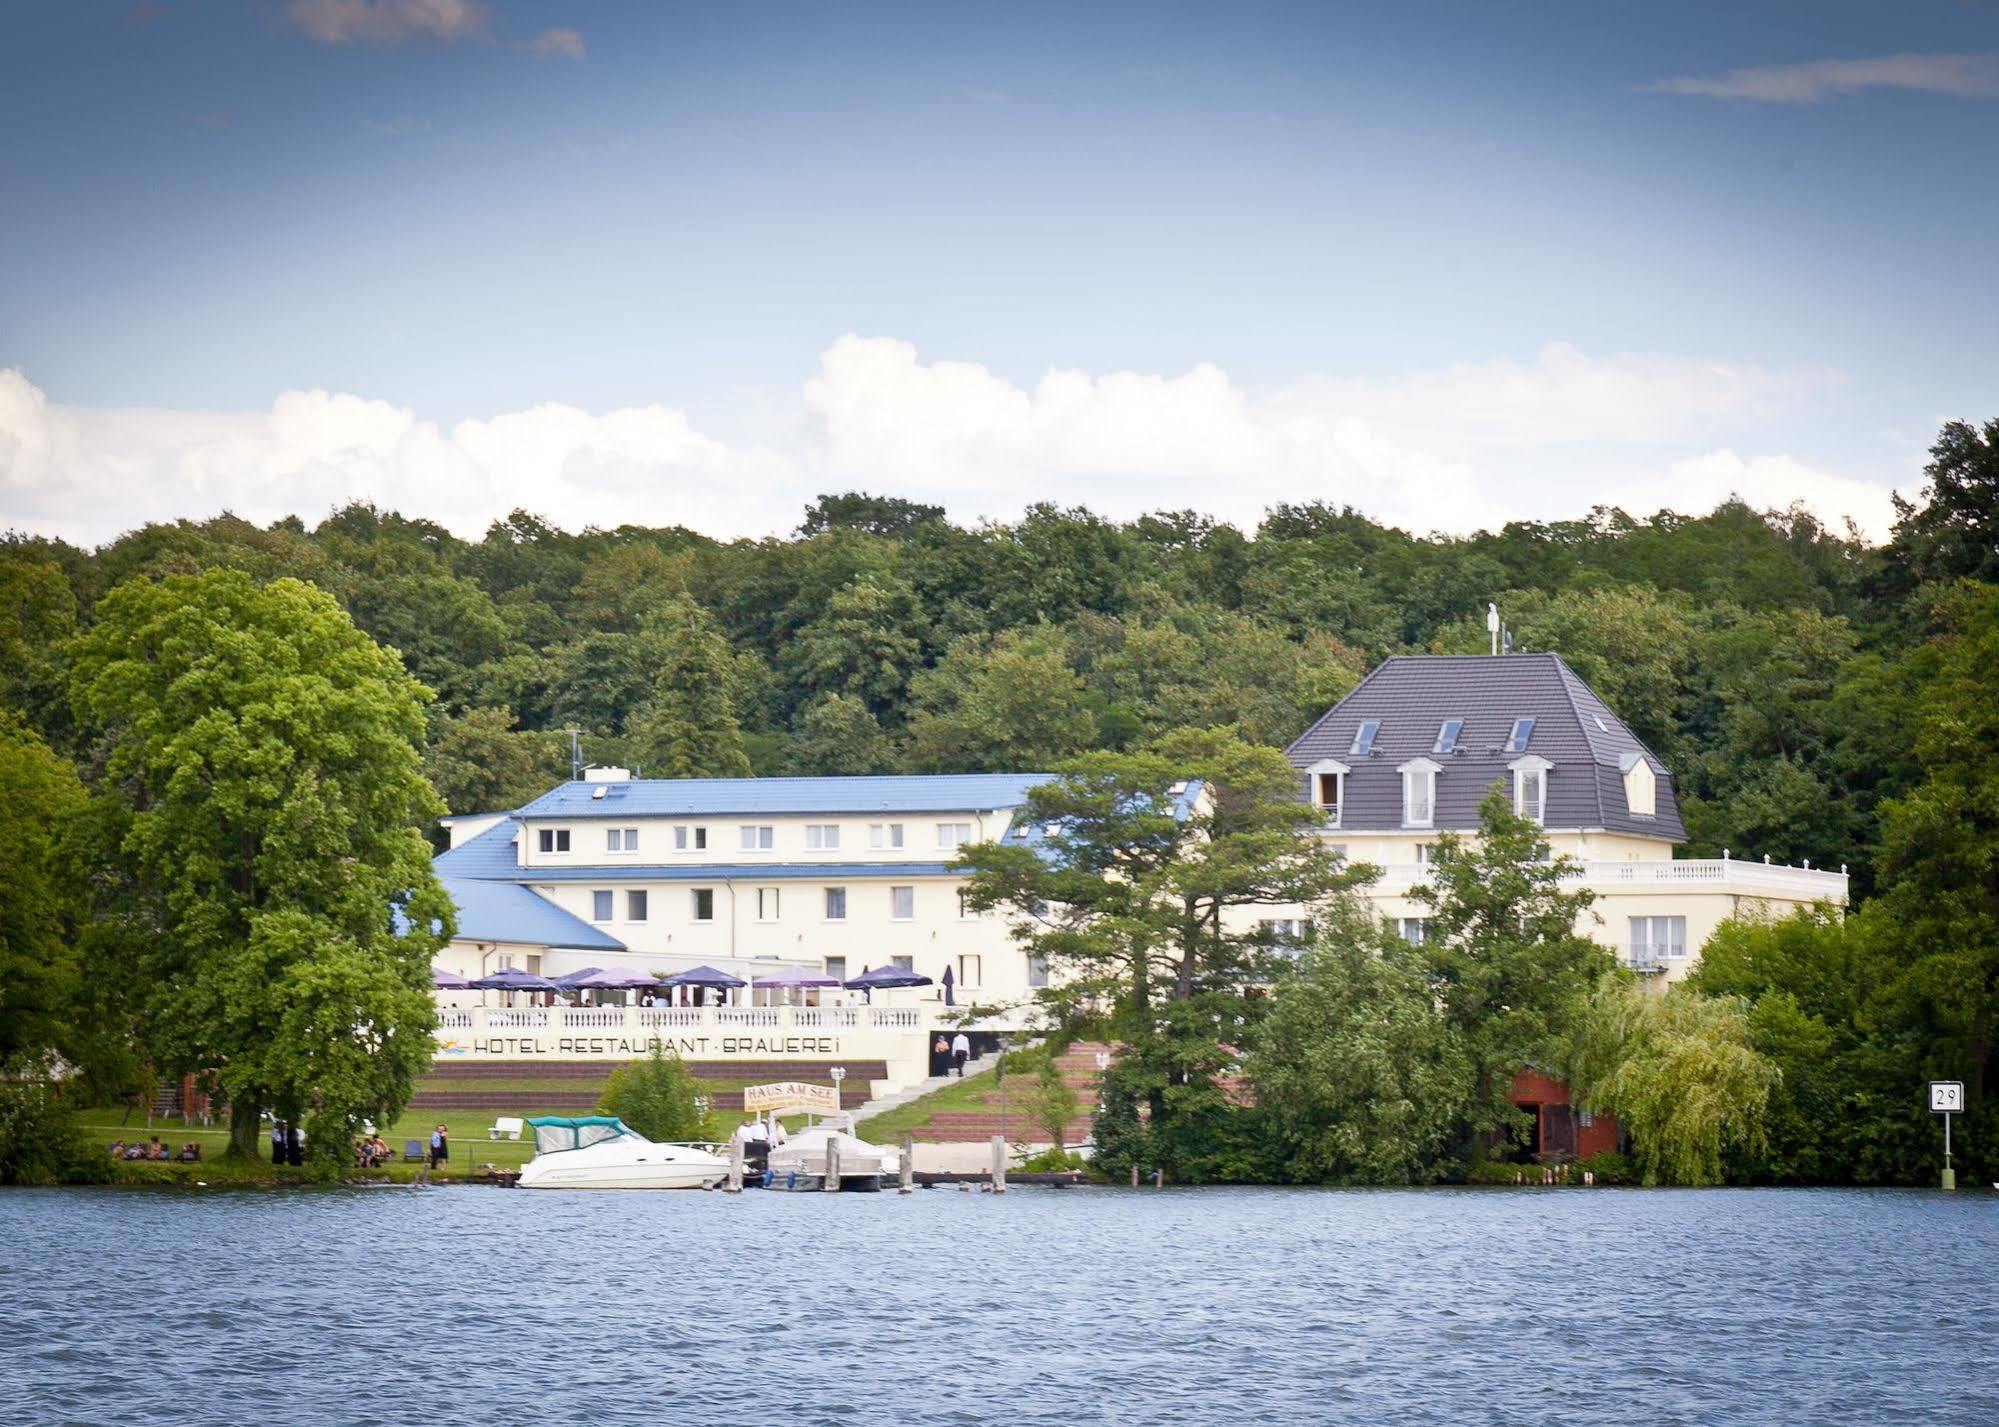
{"left": 958, "top": 727, "right": 1371, "bottom": 1177}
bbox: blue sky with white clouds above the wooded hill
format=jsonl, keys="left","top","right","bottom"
{"left": 0, "top": 0, "right": 1999, "bottom": 544}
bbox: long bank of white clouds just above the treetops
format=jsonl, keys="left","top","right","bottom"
{"left": 0, "top": 334, "right": 1891, "bottom": 544}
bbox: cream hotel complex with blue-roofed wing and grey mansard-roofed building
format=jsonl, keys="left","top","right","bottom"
{"left": 436, "top": 656, "right": 1847, "bottom": 1083}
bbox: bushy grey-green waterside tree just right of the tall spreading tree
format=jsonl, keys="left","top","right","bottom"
{"left": 1243, "top": 905, "right": 1471, "bottom": 1183}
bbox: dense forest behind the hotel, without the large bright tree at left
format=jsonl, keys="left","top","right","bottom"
{"left": 0, "top": 422, "right": 1999, "bottom": 1181}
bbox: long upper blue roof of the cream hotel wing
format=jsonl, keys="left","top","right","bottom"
{"left": 516, "top": 773, "right": 1053, "bottom": 817}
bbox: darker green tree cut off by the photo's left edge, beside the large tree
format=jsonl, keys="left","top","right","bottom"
{"left": 0, "top": 710, "right": 90, "bottom": 1067}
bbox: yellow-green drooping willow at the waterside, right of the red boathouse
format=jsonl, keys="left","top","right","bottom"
{"left": 1569, "top": 975, "right": 1779, "bottom": 1185}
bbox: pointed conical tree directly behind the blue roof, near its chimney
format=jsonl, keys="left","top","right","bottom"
{"left": 630, "top": 600, "right": 750, "bottom": 777}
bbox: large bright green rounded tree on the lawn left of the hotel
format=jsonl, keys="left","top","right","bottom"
{"left": 72, "top": 572, "right": 450, "bottom": 1157}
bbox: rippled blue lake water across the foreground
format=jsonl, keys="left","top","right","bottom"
{"left": 0, "top": 1187, "right": 1999, "bottom": 1427}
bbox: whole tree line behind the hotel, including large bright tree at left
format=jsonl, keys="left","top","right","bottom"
{"left": 0, "top": 422, "right": 1999, "bottom": 1179}
